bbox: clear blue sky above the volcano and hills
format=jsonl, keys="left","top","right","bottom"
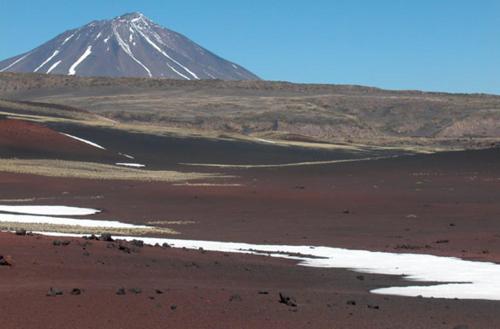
{"left": 0, "top": 0, "right": 500, "bottom": 94}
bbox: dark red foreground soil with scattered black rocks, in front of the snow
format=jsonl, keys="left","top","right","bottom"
{"left": 0, "top": 233, "right": 494, "bottom": 329}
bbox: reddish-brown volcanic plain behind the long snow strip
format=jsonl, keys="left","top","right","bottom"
{"left": 0, "top": 149, "right": 500, "bottom": 262}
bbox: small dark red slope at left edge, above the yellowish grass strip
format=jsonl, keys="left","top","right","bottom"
{"left": 0, "top": 119, "right": 117, "bottom": 161}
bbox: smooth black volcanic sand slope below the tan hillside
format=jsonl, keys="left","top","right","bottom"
{"left": 44, "top": 123, "right": 402, "bottom": 171}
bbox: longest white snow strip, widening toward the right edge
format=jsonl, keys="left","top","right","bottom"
{"left": 28, "top": 232, "right": 500, "bottom": 300}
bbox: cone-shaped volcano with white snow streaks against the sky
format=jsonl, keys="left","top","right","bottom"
{"left": 0, "top": 12, "right": 258, "bottom": 80}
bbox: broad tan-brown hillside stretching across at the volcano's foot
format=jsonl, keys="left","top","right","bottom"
{"left": 0, "top": 73, "right": 500, "bottom": 149}
